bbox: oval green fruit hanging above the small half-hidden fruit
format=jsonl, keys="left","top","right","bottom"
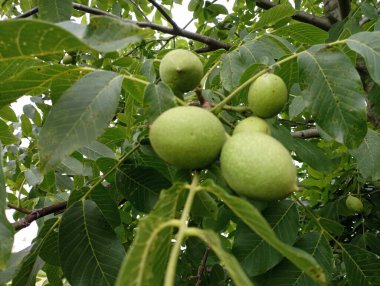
{"left": 248, "top": 73, "right": 288, "bottom": 118}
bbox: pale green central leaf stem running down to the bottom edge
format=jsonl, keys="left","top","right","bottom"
{"left": 164, "top": 173, "right": 199, "bottom": 286}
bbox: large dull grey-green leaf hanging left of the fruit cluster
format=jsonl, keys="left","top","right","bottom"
{"left": 39, "top": 71, "right": 122, "bottom": 172}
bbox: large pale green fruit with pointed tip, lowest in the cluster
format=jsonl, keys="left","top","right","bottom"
{"left": 220, "top": 132, "right": 298, "bottom": 201}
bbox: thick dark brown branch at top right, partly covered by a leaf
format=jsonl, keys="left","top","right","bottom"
{"left": 256, "top": 0, "right": 331, "bottom": 31}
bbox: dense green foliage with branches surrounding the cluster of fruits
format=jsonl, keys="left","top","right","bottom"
{"left": 0, "top": 0, "right": 380, "bottom": 286}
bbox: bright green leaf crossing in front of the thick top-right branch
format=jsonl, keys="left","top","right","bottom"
{"left": 253, "top": 3, "right": 295, "bottom": 29}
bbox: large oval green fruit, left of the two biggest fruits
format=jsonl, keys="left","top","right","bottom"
{"left": 149, "top": 106, "right": 226, "bottom": 169}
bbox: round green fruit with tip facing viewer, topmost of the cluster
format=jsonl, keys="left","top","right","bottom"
{"left": 159, "top": 49, "right": 203, "bottom": 93}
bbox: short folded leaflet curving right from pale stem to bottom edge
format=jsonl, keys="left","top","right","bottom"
{"left": 188, "top": 228, "right": 253, "bottom": 286}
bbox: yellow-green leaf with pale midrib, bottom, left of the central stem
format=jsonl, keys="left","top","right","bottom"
{"left": 116, "top": 184, "right": 185, "bottom": 286}
